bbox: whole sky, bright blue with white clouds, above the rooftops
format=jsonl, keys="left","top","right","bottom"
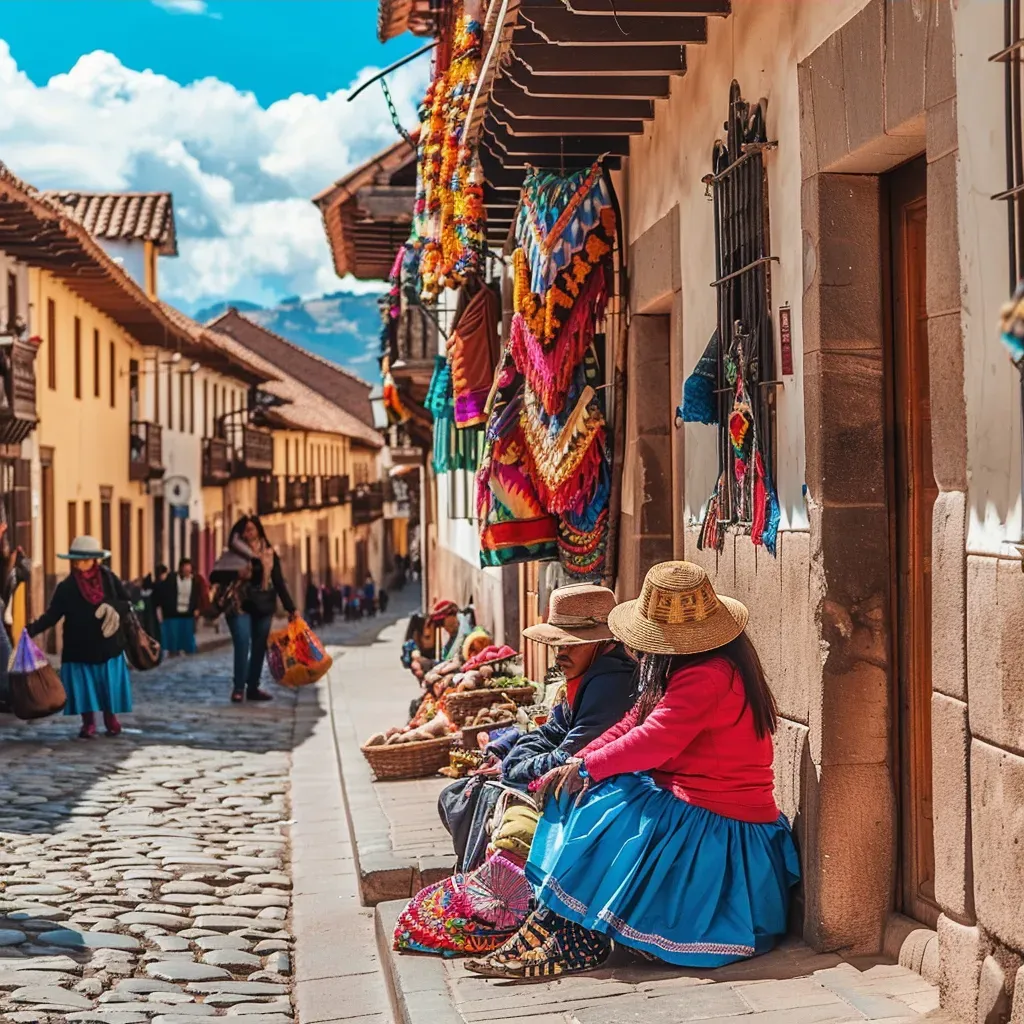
{"left": 0, "top": 0, "right": 429, "bottom": 312}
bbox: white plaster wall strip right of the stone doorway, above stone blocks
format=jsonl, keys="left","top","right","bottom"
{"left": 954, "top": 0, "right": 1022, "bottom": 555}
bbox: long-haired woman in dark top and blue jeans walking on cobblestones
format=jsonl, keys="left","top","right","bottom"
{"left": 225, "top": 515, "right": 298, "bottom": 703}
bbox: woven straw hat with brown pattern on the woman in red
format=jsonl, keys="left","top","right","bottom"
{"left": 608, "top": 562, "right": 750, "bottom": 654}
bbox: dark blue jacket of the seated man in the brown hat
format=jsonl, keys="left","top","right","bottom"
{"left": 487, "top": 644, "right": 636, "bottom": 785}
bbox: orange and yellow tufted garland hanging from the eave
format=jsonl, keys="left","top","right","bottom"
{"left": 410, "top": 14, "right": 486, "bottom": 301}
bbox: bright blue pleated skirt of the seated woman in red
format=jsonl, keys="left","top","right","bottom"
{"left": 526, "top": 774, "right": 800, "bottom": 968}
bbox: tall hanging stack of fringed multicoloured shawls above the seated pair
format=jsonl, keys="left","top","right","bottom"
{"left": 478, "top": 164, "right": 615, "bottom": 578}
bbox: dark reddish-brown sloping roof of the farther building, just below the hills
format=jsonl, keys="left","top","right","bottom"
{"left": 207, "top": 307, "right": 377, "bottom": 435}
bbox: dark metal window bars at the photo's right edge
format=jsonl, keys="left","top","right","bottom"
{"left": 988, "top": 0, "right": 1024, "bottom": 544}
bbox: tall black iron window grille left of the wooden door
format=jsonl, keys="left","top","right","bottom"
{"left": 703, "top": 81, "right": 780, "bottom": 528}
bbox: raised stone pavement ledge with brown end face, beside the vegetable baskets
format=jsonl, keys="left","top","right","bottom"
{"left": 327, "top": 655, "right": 455, "bottom": 906}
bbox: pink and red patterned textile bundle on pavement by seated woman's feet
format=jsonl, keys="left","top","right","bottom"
{"left": 394, "top": 852, "right": 534, "bottom": 956}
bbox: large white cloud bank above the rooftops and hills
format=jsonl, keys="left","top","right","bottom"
{"left": 0, "top": 40, "right": 427, "bottom": 309}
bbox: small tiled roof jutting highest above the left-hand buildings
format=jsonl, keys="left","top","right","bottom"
{"left": 43, "top": 191, "right": 178, "bottom": 256}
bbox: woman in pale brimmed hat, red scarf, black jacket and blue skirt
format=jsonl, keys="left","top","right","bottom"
{"left": 28, "top": 537, "right": 131, "bottom": 739}
